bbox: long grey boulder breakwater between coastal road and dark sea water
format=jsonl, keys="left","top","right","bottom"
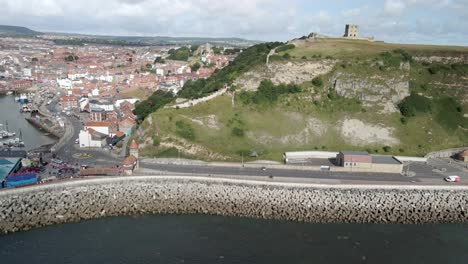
{"left": 0, "top": 176, "right": 468, "bottom": 233}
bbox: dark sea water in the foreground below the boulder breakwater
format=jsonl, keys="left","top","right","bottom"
{"left": 0, "top": 216, "right": 468, "bottom": 264}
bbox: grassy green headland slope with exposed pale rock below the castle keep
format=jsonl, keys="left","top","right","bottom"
{"left": 137, "top": 39, "right": 468, "bottom": 160}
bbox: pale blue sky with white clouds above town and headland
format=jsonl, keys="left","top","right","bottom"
{"left": 0, "top": 0, "right": 468, "bottom": 46}
